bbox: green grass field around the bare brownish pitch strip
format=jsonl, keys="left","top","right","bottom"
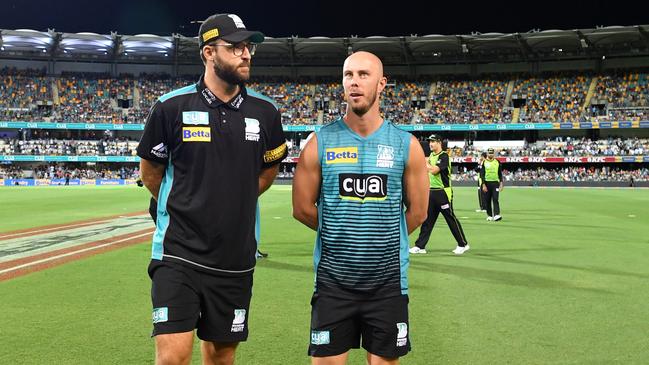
{"left": 0, "top": 186, "right": 649, "bottom": 365}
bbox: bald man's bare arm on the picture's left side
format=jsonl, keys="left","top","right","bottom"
{"left": 293, "top": 133, "right": 322, "bottom": 230}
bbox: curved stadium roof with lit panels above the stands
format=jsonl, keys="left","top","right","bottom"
{"left": 0, "top": 25, "right": 649, "bottom": 66}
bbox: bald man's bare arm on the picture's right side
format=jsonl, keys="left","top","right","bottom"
{"left": 403, "top": 136, "right": 428, "bottom": 234}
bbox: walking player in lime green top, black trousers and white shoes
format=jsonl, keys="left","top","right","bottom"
{"left": 410, "top": 134, "right": 470, "bottom": 255}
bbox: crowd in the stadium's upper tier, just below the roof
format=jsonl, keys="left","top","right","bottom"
{"left": 0, "top": 68, "right": 649, "bottom": 124}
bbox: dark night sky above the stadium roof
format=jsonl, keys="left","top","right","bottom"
{"left": 0, "top": 0, "right": 649, "bottom": 37}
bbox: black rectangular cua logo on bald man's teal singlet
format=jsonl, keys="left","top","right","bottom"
{"left": 338, "top": 174, "right": 388, "bottom": 201}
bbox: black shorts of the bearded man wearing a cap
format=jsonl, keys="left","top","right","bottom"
{"left": 149, "top": 260, "right": 252, "bottom": 342}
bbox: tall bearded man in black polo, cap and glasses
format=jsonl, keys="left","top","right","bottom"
{"left": 137, "top": 14, "right": 287, "bottom": 364}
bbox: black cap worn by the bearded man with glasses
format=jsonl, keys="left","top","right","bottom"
{"left": 198, "top": 14, "right": 264, "bottom": 49}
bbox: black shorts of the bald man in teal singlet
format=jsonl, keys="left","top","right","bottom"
{"left": 309, "top": 293, "right": 410, "bottom": 359}
